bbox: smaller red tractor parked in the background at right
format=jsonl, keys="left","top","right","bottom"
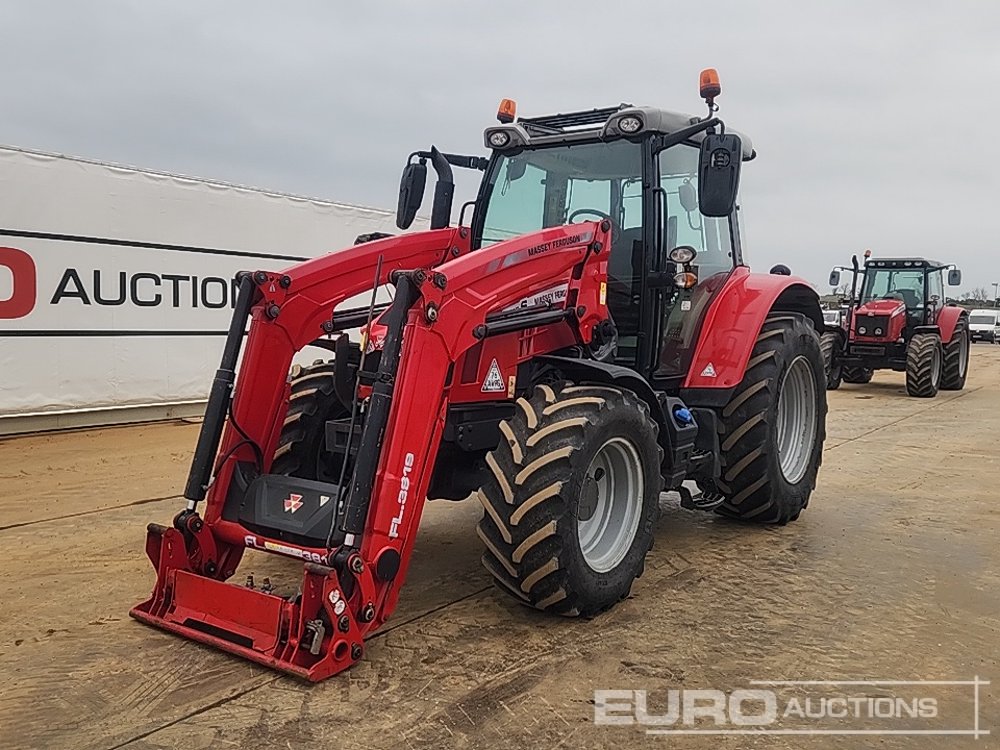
{"left": 820, "top": 251, "right": 969, "bottom": 398}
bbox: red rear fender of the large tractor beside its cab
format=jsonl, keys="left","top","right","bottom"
{"left": 683, "top": 267, "right": 824, "bottom": 388}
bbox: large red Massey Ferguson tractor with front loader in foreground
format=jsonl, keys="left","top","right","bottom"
{"left": 131, "top": 70, "right": 826, "bottom": 681}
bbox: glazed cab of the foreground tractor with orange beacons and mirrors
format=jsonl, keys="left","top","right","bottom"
{"left": 397, "top": 70, "right": 756, "bottom": 390}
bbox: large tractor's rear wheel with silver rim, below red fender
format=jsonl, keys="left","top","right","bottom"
{"left": 716, "top": 313, "right": 826, "bottom": 524}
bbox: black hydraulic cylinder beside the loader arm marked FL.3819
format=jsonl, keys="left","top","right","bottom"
{"left": 340, "top": 271, "right": 423, "bottom": 539}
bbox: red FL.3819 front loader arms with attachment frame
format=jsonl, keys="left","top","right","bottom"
{"left": 132, "top": 221, "right": 611, "bottom": 681}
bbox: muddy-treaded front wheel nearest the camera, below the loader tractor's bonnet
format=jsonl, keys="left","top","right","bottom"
{"left": 478, "top": 384, "right": 662, "bottom": 616}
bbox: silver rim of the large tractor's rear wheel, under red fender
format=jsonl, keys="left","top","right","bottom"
{"left": 777, "top": 356, "right": 817, "bottom": 484}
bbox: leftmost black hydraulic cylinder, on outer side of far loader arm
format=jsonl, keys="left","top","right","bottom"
{"left": 184, "top": 272, "right": 254, "bottom": 510}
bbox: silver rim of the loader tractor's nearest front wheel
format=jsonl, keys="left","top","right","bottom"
{"left": 577, "top": 437, "right": 645, "bottom": 573}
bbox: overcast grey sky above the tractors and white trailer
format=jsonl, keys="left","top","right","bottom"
{"left": 0, "top": 0, "right": 1000, "bottom": 293}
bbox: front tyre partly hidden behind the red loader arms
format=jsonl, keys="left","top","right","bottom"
{"left": 271, "top": 359, "right": 350, "bottom": 483}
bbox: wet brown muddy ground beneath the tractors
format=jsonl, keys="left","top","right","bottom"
{"left": 0, "top": 345, "right": 1000, "bottom": 750}
